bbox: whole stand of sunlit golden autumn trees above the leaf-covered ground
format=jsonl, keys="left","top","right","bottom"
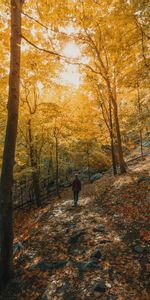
{"left": 0, "top": 0, "right": 150, "bottom": 282}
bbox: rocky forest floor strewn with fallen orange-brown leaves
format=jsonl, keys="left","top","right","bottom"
{"left": 0, "top": 157, "right": 150, "bottom": 300}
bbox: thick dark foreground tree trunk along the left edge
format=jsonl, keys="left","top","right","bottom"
{"left": 0, "top": 0, "right": 23, "bottom": 283}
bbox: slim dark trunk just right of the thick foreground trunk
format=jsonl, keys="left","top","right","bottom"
{"left": 28, "top": 119, "right": 41, "bottom": 207}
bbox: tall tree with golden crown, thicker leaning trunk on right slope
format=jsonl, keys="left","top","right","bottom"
{"left": 70, "top": 0, "right": 126, "bottom": 173}
